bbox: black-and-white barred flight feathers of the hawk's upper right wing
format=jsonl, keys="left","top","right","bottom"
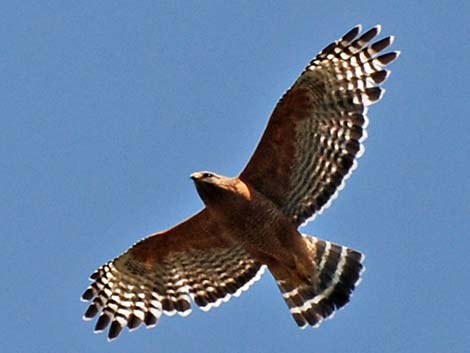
{"left": 281, "top": 25, "right": 399, "bottom": 224}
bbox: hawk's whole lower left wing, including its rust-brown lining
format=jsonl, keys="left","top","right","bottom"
{"left": 82, "top": 210, "right": 264, "bottom": 339}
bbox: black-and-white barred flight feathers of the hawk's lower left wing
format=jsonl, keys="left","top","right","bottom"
{"left": 82, "top": 246, "right": 265, "bottom": 340}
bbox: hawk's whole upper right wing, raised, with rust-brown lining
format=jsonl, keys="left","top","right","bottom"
{"left": 240, "top": 26, "right": 399, "bottom": 225}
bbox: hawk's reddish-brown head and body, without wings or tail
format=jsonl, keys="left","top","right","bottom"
{"left": 191, "top": 172, "right": 315, "bottom": 281}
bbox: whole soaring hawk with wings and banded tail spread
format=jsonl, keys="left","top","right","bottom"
{"left": 82, "top": 26, "right": 399, "bottom": 340}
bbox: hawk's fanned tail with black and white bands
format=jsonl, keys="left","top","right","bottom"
{"left": 277, "top": 236, "right": 364, "bottom": 328}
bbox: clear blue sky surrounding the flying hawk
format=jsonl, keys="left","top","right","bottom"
{"left": 0, "top": 1, "right": 470, "bottom": 353}
